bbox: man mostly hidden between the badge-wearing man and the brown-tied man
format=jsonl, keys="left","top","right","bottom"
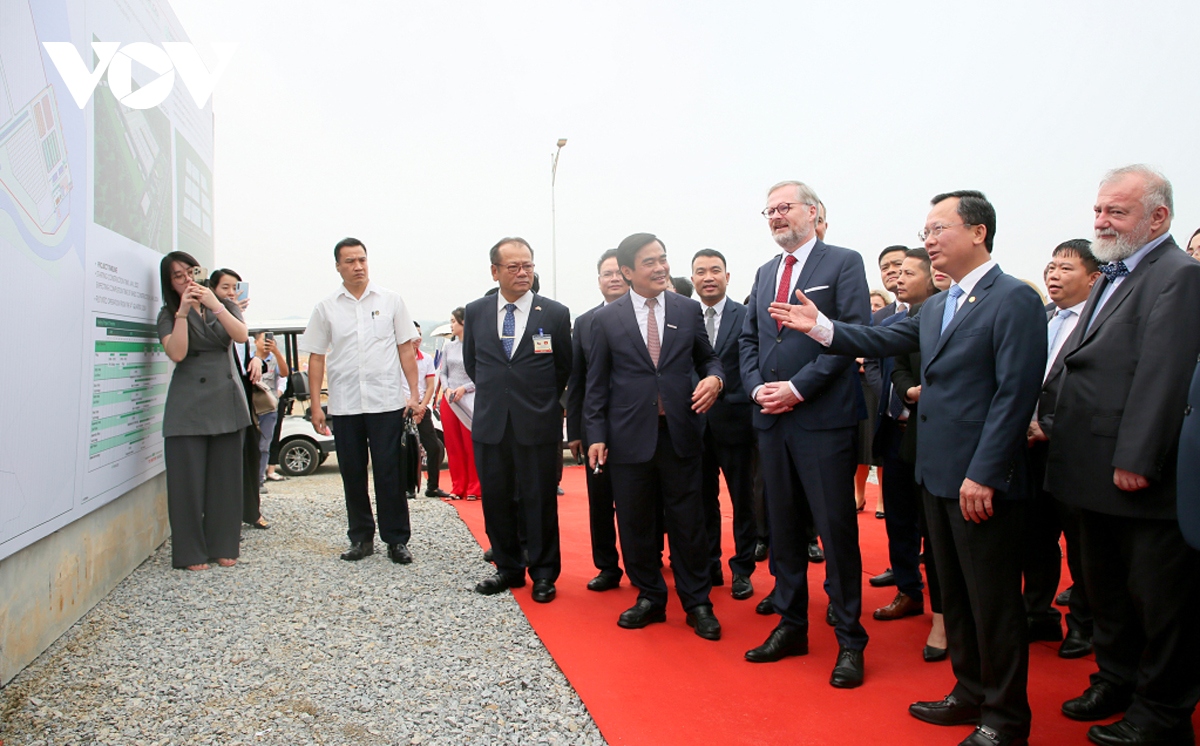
{"left": 566, "top": 248, "right": 629, "bottom": 591}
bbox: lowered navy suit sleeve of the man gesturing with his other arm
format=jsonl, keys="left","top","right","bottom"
{"left": 952, "top": 284, "right": 1046, "bottom": 489}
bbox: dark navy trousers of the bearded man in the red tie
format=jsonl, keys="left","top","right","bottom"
{"left": 758, "top": 424, "right": 866, "bottom": 650}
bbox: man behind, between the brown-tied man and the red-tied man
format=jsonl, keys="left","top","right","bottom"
{"left": 691, "top": 248, "right": 756, "bottom": 601}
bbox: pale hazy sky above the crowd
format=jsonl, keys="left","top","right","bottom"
{"left": 172, "top": 0, "right": 1200, "bottom": 319}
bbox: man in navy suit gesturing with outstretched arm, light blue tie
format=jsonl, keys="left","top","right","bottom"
{"left": 772, "top": 191, "right": 1046, "bottom": 746}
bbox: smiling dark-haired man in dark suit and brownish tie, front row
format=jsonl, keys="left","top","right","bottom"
{"left": 583, "top": 233, "right": 722, "bottom": 640}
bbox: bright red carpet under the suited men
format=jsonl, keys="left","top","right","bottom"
{"left": 452, "top": 467, "right": 1190, "bottom": 746}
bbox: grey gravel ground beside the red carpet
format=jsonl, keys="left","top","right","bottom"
{"left": 0, "top": 459, "right": 605, "bottom": 746}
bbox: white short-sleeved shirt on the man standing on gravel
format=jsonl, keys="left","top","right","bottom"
{"left": 299, "top": 283, "right": 419, "bottom": 415}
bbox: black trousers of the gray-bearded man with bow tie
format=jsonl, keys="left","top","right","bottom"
{"left": 1072, "top": 510, "right": 1200, "bottom": 728}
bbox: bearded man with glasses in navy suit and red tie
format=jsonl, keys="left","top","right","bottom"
{"left": 740, "top": 181, "right": 871, "bottom": 687}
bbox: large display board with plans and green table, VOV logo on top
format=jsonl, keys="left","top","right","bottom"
{"left": 0, "top": 0, "right": 212, "bottom": 559}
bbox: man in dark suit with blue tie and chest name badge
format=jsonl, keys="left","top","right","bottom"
{"left": 462, "top": 237, "right": 571, "bottom": 603}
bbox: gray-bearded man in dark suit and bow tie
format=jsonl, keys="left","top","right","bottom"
{"left": 1046, "top": 166, "right": 1200, "bottom": 745}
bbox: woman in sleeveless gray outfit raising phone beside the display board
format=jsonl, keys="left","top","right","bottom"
{"left": 158, "top": 252, "right": 250, "bottom": 570}
